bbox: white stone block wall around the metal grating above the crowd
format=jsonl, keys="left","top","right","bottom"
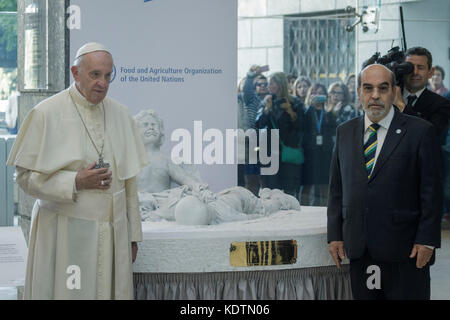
{"left": 238, "top": 0, "right": 428, "bottom": 80}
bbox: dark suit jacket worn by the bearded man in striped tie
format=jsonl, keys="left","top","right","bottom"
{"left": 328, "top": 108, "right": 443, "bottom": 262}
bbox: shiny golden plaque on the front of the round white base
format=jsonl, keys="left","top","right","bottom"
{"left": 230, "top": 240, "right": 297, "bottom": 267}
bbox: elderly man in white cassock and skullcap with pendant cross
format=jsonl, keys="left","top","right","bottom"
{"left": 8, "top": 43, "right": 148, "bottom": 299}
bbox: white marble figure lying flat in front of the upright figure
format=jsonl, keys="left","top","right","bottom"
{"left": 140, "top": 186, "right": 300, "bottom": 225}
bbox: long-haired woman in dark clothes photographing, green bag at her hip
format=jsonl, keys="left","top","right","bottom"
{"left": 256, "top": 72, "right": 304, "bottom": 197}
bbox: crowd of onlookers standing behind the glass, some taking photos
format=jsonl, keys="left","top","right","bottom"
{"left": 238, "top": 65, "right": 363, "bottom": 206}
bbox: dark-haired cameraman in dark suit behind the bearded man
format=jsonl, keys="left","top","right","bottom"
{"left": 394, "top": 47, "right": 450, "bottom": 139}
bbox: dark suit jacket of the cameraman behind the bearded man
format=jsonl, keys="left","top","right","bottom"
{"left": 403, "top": 89, "right": 450, "bottom": 137}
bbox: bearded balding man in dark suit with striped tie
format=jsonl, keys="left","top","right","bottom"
{"left": 328, "top": 64, "right": 443, "bottom": 299}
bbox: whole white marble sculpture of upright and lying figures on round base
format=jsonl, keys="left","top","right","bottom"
{"left": 135, "top": 110, "right": 300, "bottom": 225}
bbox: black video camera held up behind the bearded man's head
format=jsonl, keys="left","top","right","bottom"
{"left": 363, "top": 47, "right": 414, "bottom": 92}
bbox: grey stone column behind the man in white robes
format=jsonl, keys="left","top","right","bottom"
{"left": 17, "top": 0, "right": 69, "bottom": 242}
